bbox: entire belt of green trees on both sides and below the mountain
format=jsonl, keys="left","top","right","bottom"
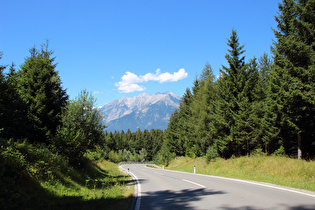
{"left": 0, "top": 0, "right": 315, "bottom": 169}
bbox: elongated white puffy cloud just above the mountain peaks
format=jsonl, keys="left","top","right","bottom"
{"left": 115, "top": 69, "right": 188, "bottom": 93}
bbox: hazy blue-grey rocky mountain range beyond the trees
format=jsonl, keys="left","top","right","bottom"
{"left": 100, "top": 92, "right": 180, "bottom": 132}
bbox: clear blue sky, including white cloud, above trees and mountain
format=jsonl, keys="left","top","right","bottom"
{"left": 0, "top": 0, "right": 280, "bottom": 106}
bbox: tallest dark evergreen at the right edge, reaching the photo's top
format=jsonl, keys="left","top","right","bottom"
{"left": 269, "top": 0, "right": 315, "bottom": 159}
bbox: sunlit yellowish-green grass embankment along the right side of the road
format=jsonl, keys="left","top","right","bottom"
{"left": 167, "top": 155, "right": 315, "bottom": 191}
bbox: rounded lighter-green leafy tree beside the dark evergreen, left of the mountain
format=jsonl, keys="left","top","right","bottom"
{"left": 53, "top": 91, "right": 105, "bottom": 163}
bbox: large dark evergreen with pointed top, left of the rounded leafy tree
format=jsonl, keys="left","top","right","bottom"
{"left": 18, "top": 43, "right": 68, "bottom": 144}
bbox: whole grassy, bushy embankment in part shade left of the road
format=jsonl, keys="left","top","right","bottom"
{"left": 0, "top": 140, "right": 133, "bottom": 209}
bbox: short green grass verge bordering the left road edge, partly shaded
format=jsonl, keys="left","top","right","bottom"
{"left": 40, "top": 161, "right": 133, "bottom": 209}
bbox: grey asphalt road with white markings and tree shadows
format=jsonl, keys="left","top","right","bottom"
{"left": 121, "top": 165, "right": 315, "bottom": 210}
